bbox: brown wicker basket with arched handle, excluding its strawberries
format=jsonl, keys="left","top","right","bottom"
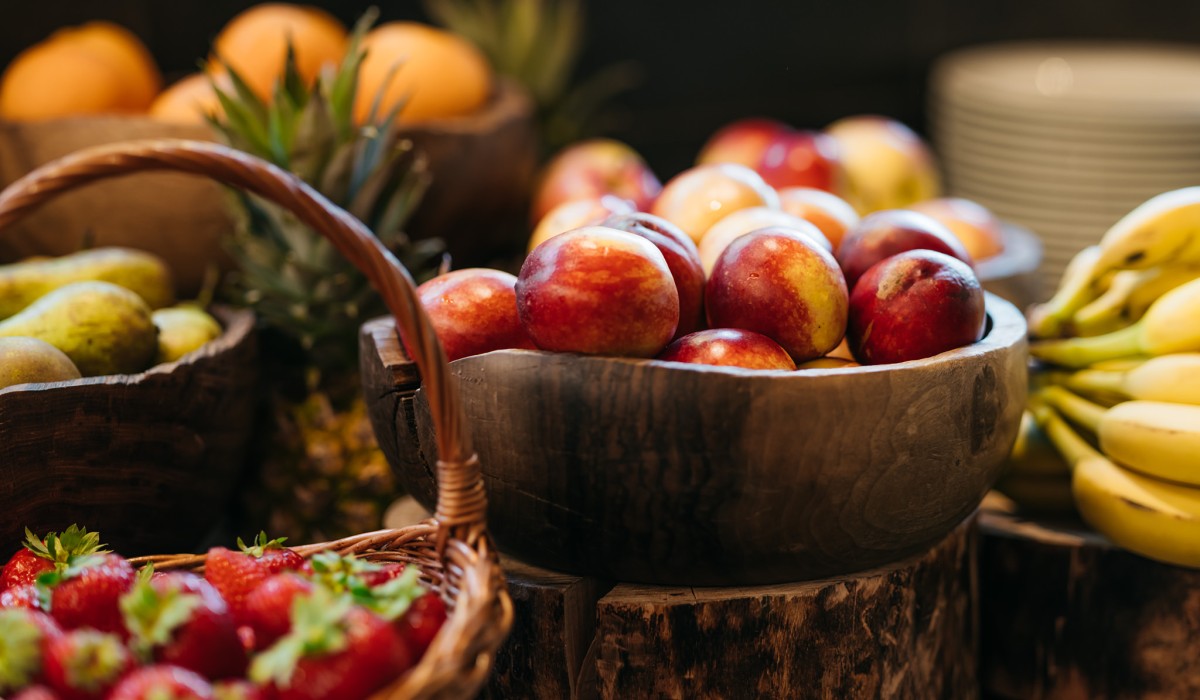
{"left": 0, "top": 140, "right": 512, "bottom": 700}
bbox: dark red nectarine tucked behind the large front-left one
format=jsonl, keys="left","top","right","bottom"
{"left": 601, "top": 211, "right": 704, "bottom": 337}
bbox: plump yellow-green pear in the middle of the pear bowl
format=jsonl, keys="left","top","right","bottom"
{"left": 0, "top": 281, "right": 158, "bottom": 377}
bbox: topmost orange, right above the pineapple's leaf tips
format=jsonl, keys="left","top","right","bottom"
{"left": 209, "top": 2, "right": 349, "bottom": 100}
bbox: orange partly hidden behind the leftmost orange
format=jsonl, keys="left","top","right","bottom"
{"left": 50, "top": 22, "right": 162, "bottom": 112}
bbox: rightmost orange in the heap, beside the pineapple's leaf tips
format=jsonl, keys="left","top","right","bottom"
{"left": 354, "top": 22, "right": 492, "bottom": 122}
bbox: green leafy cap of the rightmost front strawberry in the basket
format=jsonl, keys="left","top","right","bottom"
{"left": 250, "top": 586, "right": 354, "bottom": 688}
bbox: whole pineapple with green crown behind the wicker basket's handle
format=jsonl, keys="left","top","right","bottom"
{"left": 210, "top": 16, "right": 443, "bottom": 542}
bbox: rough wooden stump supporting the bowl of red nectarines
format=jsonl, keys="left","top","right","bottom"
{"left": 491, "top": 516, "right": 979, "bottom": 700}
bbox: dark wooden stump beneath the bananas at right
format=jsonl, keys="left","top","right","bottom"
{"left": 979, "top": 503, "right": 1200, "bottom": 700}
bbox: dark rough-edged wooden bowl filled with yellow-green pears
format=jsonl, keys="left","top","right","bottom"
{"left": 0, "top": 247, "right": 257, "bottom": 555}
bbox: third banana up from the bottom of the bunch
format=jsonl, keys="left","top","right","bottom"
{"left": 1060, "top": 353, "right": 1200, "bottom": 406}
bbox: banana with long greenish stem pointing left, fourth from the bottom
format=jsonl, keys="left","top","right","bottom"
{"left": 1030, "top": 279, "right": 1200, "bottom": 367}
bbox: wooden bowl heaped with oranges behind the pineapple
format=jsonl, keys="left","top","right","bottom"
{"left": 0, "top": 4, "right": 536, "bottom": 294}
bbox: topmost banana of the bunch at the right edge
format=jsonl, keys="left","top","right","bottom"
{"left": 1094, "top": 187, "right": 1200, "bottom": 274}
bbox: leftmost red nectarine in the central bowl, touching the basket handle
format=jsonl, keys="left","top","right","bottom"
{"left": 416, "top": 268, "right": 534, "bottom": 360}
